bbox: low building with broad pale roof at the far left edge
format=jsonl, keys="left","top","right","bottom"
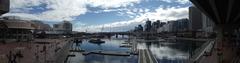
{"left": 0, "top": 19, "right": 36, "bottom": 42}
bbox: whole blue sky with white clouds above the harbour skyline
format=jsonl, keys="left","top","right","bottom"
{"left": 3, "top": 0, "right": 192, "bottom": 32}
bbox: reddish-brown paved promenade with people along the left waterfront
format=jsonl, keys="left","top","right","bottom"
{"left": 0, "top": 39, "right": 72, "bottom": 63}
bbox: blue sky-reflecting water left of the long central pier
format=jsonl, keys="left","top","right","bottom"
{"left": 68, "top": 39, "right": 137, "bottom": 63}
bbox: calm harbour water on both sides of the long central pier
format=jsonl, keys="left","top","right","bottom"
{"left": 68, "top": 39, "right": 201, "bottom": 63}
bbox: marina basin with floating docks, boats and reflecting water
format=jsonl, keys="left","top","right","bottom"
{"left": 67, "top": 39, "right": 201, "bottom": 63}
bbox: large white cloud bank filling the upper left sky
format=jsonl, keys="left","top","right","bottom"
{"left": 4, "top": 0, "right": 140, "bottom": 21}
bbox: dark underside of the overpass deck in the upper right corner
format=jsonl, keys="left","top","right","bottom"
{"left": 190, "top": 0, "right": 240, "bottom": 29}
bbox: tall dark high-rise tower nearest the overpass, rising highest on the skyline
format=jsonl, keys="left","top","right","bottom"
{"left": 189, "top": 6, "right": 203, "bottom": 31}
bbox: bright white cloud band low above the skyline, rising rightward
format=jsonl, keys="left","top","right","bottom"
{"left": 77, "top": 7, "right": 188, "bottom": 32}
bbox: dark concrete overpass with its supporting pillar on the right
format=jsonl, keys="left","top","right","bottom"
{"left": 190, "top": 0, "right": 240, "bottom": 63}
